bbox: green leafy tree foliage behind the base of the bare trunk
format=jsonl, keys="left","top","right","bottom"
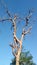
{"left": 10, "top": 51, "right": 36, "bottom": 65}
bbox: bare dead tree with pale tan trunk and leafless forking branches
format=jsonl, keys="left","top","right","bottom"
{"left": 0, "top": 5, "right": 32, "bottom": 65}
